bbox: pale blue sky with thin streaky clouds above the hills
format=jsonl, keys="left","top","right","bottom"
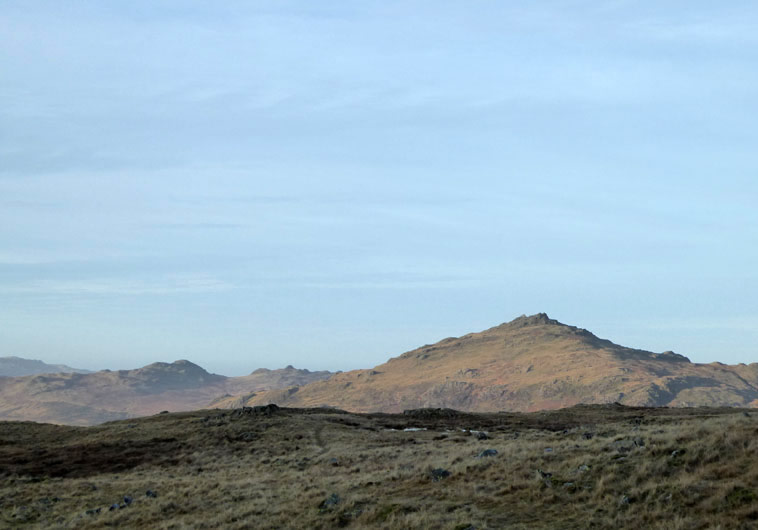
{"left": 0, "top": 0, "right": 758, "bottom": 375}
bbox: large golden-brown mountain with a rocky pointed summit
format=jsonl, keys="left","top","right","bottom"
{"left": 229, "top": 313, "right": 758, "bottom": 412}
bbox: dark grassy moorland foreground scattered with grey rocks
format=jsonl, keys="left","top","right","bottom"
{"left": 0, "top": 405, "right": 758, "bottom": 529}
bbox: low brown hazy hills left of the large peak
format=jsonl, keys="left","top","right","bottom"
{"left": 0, "top": 360, "right": 331, "bottom": 425}
